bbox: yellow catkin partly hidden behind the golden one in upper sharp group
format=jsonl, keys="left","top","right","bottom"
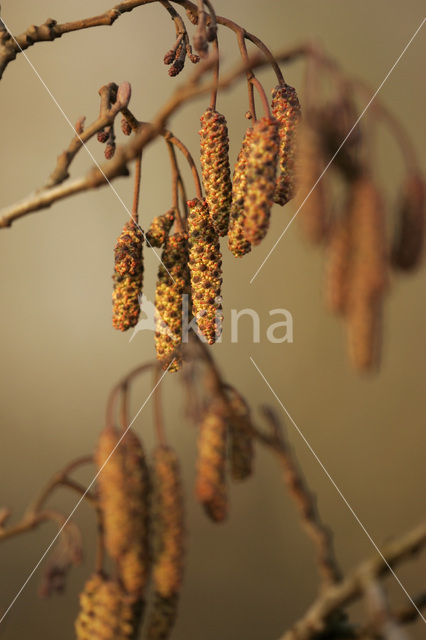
{"left": 228, "top": 127, "right": 253, "bottom": 258}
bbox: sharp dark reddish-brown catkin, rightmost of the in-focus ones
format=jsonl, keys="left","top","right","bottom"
{"left": 272, "top": 84, "right": 301, "bottom": 206}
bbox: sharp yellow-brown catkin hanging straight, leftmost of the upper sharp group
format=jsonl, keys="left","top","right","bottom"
{"left": 200, "top": 108, "right": 232, "bottom": 236}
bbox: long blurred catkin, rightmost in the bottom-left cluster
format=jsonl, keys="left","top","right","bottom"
{"left": 147, "top": 446, "right": 184, "bottom": 640}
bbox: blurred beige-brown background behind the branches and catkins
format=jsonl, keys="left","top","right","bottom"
{"left": 0, "top": 0, "right": 426, "bottom": 640}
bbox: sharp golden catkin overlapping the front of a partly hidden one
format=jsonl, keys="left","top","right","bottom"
{"left": 244, "top": 116, "right": 278, "bottom": 245}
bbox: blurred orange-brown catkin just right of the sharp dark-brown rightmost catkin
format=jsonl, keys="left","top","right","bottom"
{"left": 296, "top": 124, "right": 329, "bottom": 244}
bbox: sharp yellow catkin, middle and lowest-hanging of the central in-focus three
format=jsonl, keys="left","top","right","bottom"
{"left": 155, "top": 232, "right": 190, "bottom": 371}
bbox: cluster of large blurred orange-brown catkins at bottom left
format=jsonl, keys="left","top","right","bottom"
{"left": 75, "top": 427, "right": 184, "bottom": 640}
